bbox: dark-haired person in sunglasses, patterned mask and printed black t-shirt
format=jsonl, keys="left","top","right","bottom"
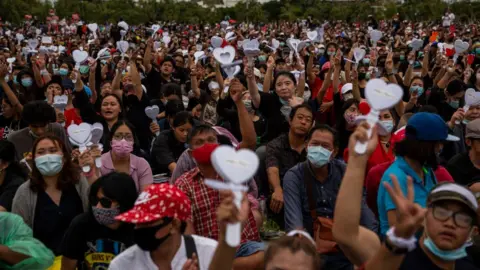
{"left": 62, "top": 172, "right": 138, "bottom": 270}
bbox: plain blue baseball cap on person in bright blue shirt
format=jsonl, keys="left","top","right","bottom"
{"left": 405, "top": 112, "right": 460, "bottom": 141}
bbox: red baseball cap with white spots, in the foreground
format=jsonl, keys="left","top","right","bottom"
{"left": 115, "top": 184, "right": 191, "bottom": 224}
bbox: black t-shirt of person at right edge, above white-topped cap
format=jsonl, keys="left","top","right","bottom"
{"left": 447, "top": 152, "right": 480, "bottom": 185}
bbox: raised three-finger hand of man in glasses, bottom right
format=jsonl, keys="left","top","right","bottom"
{"left": 383, "top": 174, "right": 427, "bottom": 239}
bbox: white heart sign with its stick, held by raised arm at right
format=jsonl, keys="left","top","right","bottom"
{"left": 355, "top": 79, "right": 403, "bottom": 154}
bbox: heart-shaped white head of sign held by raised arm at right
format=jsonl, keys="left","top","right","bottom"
{"left": 365, "top": 79, "right": 403, "bottom": 111}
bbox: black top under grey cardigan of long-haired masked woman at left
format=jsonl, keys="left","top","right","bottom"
{"left": 33, "top": 185, "right": 83, "bottom": 255}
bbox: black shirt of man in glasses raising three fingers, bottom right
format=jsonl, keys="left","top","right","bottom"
{"left": 399, "top": 245, "right": 478, "bottom": 270}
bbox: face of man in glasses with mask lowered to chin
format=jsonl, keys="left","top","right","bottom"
{"left": 425, "top": 201, "right": 473, "bottom": 251}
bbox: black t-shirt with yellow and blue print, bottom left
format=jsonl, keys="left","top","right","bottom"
{"left": 61, "top": 212, "right": 133, "bottom": 270}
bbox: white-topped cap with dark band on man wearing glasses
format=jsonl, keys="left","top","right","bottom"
{"left": 427, "top": 183, "right": 478, "bottom": 213}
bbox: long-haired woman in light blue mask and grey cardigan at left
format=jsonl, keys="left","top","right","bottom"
{"left": 12, "top": 136, "right": 88, "bottom": 255}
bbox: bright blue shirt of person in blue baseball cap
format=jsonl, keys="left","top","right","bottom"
{"left": 377, "top": 156, "right": 437, "bottom": 235}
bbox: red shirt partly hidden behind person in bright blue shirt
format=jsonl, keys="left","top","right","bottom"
{"left": 365, "top": 160, "right": 454, "bottom": 218}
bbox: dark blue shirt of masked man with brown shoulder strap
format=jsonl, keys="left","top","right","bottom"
{"left": 283, "top": 159, "right": 377, "bottom": 235}
